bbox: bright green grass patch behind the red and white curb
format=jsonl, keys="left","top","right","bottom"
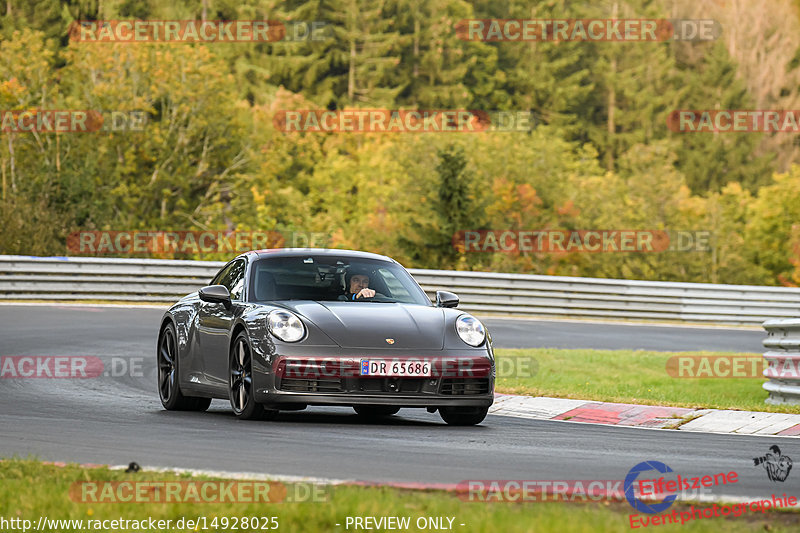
{"left": 495, "top": 348, "right": 800, "bottom": 414}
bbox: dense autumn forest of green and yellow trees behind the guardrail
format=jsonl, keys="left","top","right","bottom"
{"left": 0, "top": 0, "right": 800, "bottom": 285}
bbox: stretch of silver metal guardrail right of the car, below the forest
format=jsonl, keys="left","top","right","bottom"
{"left": 411, "top": 270, "right": 800, "bottom": 325}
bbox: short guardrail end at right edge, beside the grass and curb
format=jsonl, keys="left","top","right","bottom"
{"left": 762, "top": 318, "right": 800, "bottom": 405}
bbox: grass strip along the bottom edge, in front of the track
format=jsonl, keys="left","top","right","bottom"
{"left": 0, "top": 459, "right": 800, "bottom": 533}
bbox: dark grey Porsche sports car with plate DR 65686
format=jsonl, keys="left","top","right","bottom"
{"left": 157, "top": 249, "right": 495, "bottom": 425}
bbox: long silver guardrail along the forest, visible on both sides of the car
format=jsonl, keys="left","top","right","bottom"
{"left": 0, "top": 255, "right": 800, "bottom": 325}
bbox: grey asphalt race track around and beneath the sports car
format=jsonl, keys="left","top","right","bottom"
{"left": 0, "top": 304, "right": 788, "bottom": 498}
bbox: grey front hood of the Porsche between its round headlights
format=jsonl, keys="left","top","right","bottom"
{"left": 281, "top": 301, "right": 445, "bottom": 350}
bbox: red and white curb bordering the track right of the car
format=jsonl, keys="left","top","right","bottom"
{"left": 489, "top": 394, "right": 800, "bottom": 437}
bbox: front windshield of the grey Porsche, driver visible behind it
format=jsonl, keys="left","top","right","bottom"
{"left": 250, "top": 255, "right": 431, "bottom": 305}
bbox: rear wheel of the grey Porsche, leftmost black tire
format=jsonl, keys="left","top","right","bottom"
{"left": 156, "top": 323, "right": 211, "bottom": 411}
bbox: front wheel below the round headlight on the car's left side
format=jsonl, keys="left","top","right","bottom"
{"left": 228, "top": 331, "right": 278, "bottom": 420}
